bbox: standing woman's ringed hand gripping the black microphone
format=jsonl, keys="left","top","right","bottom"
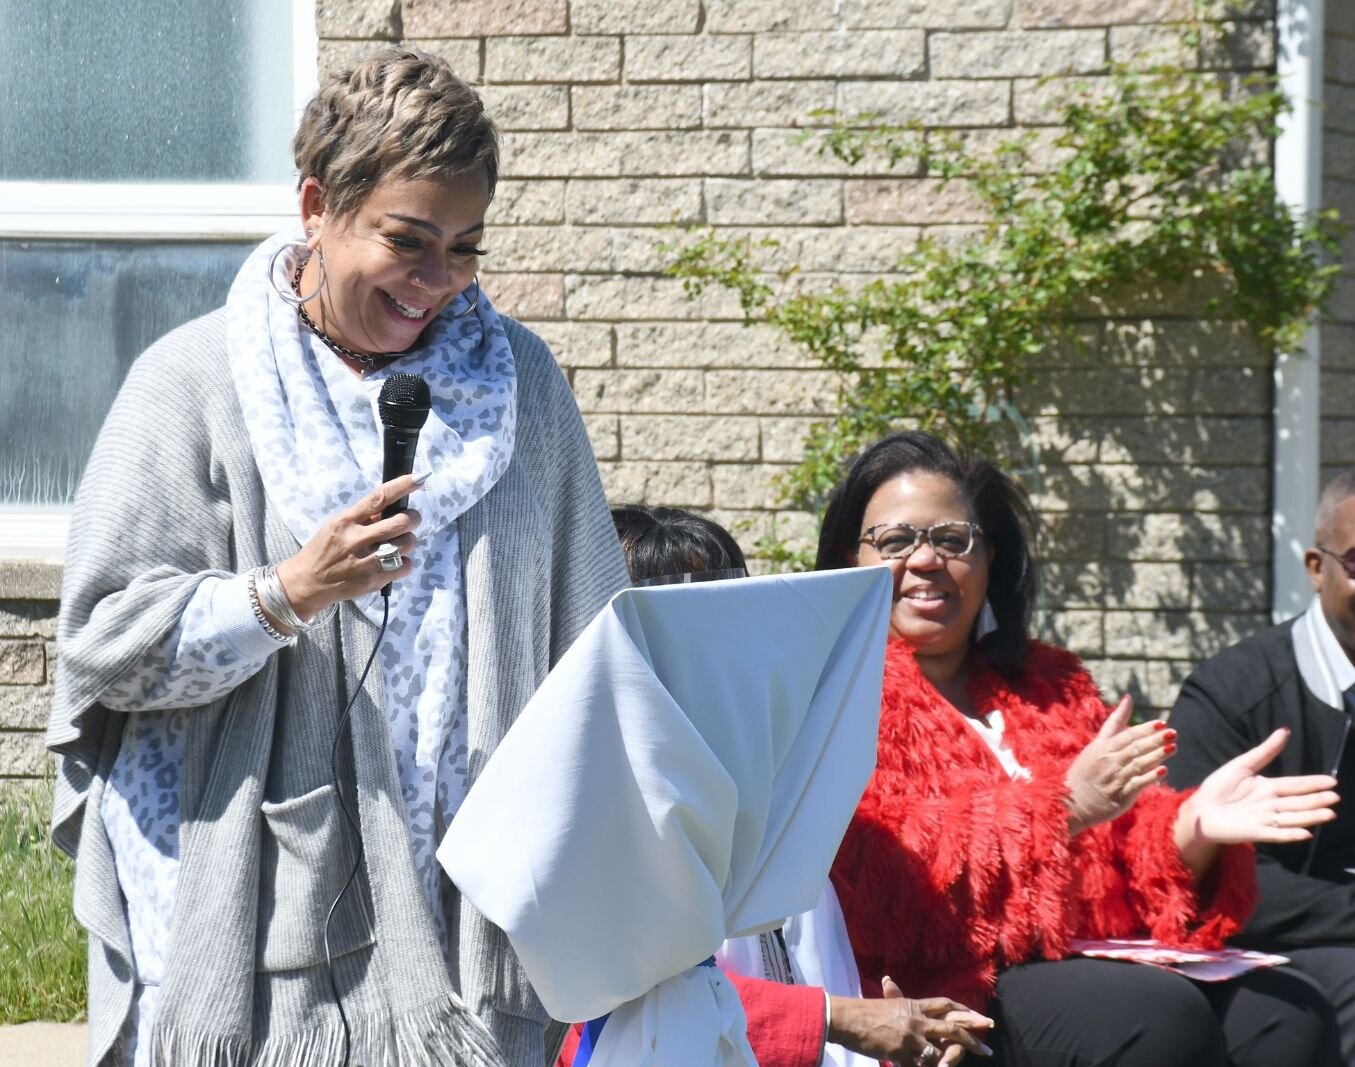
{"left": 278, "top": 475, "right": 420, "bottom": 618}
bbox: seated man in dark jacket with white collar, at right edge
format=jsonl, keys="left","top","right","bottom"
{"left": 1168, "top": 469, "right": 1355, "bottom": 1067}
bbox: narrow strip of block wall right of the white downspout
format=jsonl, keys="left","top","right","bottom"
{"left": 1321, "top": 3, "right": 1355, "bottom": 476}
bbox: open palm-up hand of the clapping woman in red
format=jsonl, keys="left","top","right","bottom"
{"left": 1176, "top": 729, "right": 1340, "bottom": 877}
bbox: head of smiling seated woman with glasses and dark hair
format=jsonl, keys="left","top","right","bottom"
{"left": 816, "top": 431, "right": 1037, "bottom": 672}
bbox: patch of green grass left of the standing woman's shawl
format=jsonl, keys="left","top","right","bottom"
{"left": 0, "top": 782, "right": 85, "bottom": 1025}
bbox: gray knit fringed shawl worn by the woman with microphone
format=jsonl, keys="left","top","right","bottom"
{"left": 47, "top": 310, "right": 626, "bottom": 1067}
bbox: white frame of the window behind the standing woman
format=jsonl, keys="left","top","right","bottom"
{"left": 0, "top": 0, "right": 318, "bottom": 564}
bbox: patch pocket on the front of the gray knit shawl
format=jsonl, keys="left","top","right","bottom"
{"left": 255, "top": 784, "right": 375, "bottom": 971}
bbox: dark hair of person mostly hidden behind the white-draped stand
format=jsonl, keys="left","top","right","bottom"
{"left": 611, "top": 504, "right": 747, "bottom": 582}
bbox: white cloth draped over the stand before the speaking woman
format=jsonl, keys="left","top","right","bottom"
{"left": 438, "top": 568, "right": 892, "bottom": 1067}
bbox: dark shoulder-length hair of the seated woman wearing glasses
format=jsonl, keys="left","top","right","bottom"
{"left": 814, "top": 430, "right": 1038, "bottom": 675}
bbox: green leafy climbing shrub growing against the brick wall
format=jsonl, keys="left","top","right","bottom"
{"left": 669, "top": 4, "right": 1337, "bottom": 565}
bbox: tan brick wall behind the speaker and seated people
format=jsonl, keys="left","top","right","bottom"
{"left": 0, "top": 0, "right": 1327, "bottom": 774}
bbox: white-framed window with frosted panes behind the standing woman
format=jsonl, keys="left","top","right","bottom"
{"left": 0, "top": 0, "right": 316, "bottom": 559}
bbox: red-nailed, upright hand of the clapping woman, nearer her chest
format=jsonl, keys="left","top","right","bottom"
{"left": 1064, "top": 696, "right": 1176, "bottom": 834}
